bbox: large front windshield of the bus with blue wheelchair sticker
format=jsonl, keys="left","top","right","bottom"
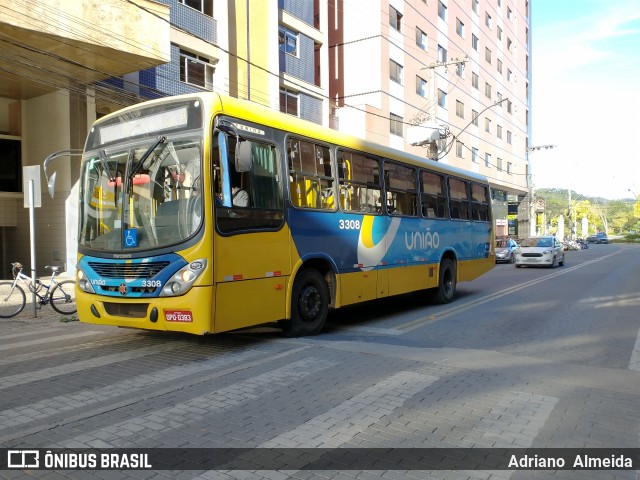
{"left": 79, "top": 135, "right": 202, "bottom": 252}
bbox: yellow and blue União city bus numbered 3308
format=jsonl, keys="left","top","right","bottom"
{"left": 76, "top": 93, "right": 495, "bottom": 336}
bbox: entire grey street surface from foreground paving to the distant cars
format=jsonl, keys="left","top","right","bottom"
{"left": 0, "top": 245, "right": 640, "bottom": 479}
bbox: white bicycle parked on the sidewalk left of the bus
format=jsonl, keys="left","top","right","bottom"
{"left": 0, "top": 262, "right": 77, "bottom": 318}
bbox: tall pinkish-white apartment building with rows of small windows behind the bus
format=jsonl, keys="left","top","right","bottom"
{"left": 329, "top": 0, "right": 531, "bottom": 235}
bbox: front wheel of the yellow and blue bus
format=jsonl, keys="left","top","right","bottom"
{"left": 280, "top": 269, "right": 329, "bottom": 337}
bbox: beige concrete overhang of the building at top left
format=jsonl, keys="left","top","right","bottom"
{"left": 0, "top": 0, "right": 171, "bottom": 99}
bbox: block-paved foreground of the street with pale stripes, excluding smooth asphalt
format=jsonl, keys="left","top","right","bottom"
{"left": 0, "top": 312, "right": 640, "bottom": 480}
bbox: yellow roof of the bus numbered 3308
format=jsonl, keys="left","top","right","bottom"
{"left": 96, "top": 92, "right": 489, "bottom": 184}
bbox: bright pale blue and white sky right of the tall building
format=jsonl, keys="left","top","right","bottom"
{"left": 529, "top": 0, "right": 640, "bottom": 200}
